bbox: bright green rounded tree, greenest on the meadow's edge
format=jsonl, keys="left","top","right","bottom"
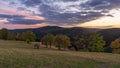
{"left": 88, "top": 33, "right": 105, "bottom": 52}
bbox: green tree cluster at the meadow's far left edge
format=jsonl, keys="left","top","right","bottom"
{"left": 0, "top": 28, "right": 36, "bottom": 43}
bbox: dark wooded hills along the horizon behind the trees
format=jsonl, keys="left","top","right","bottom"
{"left": 7, "top": 26, "right": 120, "bottom": 52}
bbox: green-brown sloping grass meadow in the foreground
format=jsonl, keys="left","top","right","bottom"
{"left": 0, "top": 40, "right": 120, "bottom": 68}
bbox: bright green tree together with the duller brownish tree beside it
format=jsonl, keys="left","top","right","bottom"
{"left": 76, "top": 33, "right": 105, "bottom": 52}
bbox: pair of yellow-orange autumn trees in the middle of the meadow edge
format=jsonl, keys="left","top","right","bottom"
{"left": 41, "top": 34, "right": 71, "bottom": 50}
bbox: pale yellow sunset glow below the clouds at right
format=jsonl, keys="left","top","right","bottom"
{"left": 76, "top": 9, "right": 120, "bottom": 28}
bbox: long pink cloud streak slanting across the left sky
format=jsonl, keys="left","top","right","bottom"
{"left": 0, "top": 8, "right": 45, "bottom": 20}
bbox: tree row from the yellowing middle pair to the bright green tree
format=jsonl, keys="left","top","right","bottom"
{"left": 42, "top": 33, "right": 105, "bottom": 52}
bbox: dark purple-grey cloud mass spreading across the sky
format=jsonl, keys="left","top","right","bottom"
{"left": 1, "top": 0, "right": 120, "bottom": 24}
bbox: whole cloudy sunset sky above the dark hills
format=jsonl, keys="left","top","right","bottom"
{"left": 0, "top": 0, "right": 120, "bottom": 29}
